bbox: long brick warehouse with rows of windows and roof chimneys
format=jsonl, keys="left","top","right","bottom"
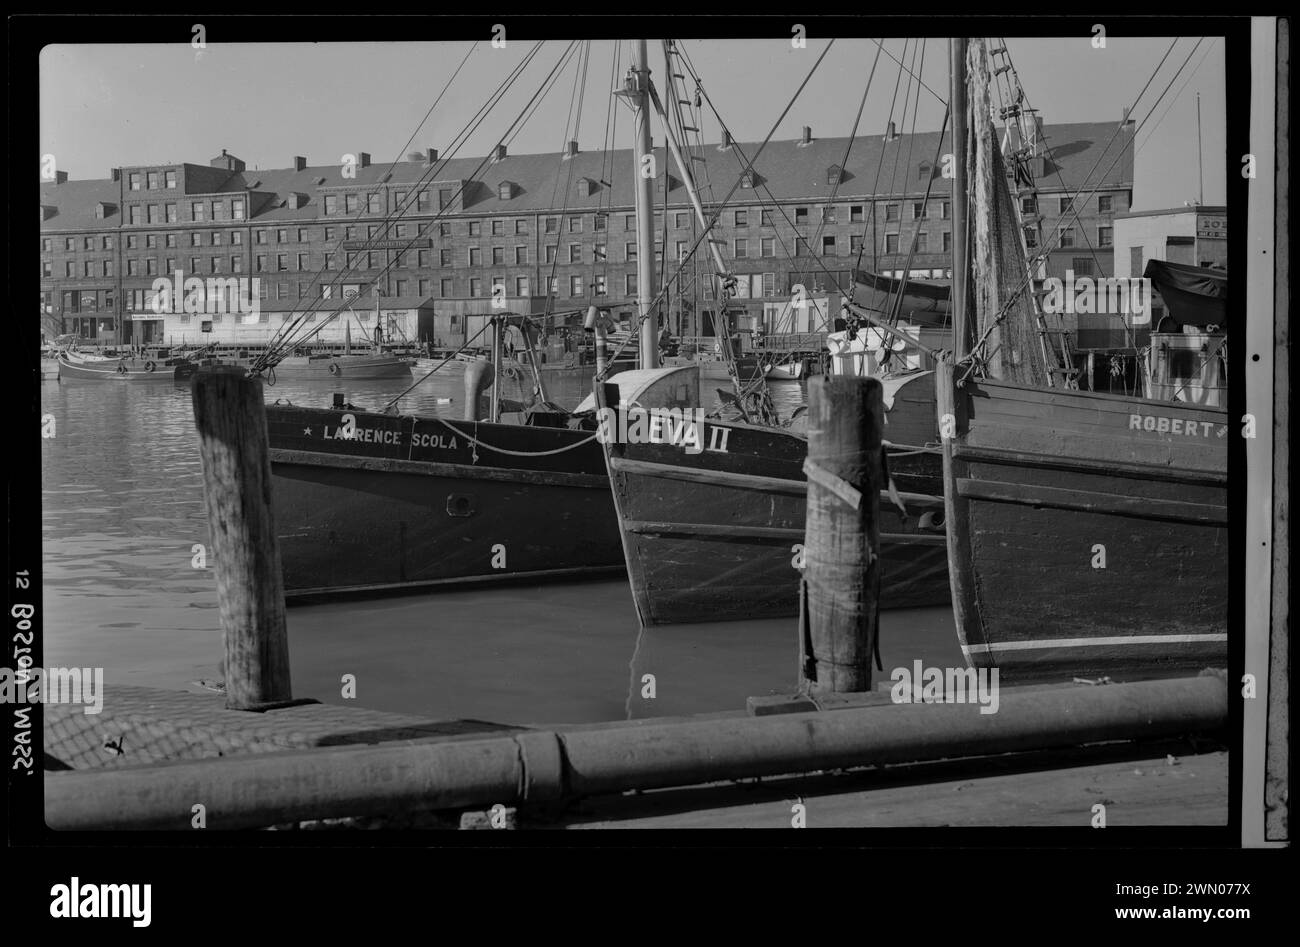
{"left": 40, "top": 122, "right": 1134, "bottom": 342}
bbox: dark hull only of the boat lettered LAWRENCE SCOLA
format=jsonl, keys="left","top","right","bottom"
{"left": 267, "top": 405, "right": 623, "bottom": 596}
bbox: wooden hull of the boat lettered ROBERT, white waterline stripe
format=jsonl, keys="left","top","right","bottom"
{"left": 936, "top": 371, "right": 1229, "bottom": 680}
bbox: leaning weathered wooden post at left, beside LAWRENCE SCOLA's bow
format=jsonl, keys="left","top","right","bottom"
{"left": 191, "top": 368, "right": 293, "bottom": 710}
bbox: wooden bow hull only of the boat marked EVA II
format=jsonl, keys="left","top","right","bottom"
{"left": 595, "top": 379, "right": 949, "bottom": 624}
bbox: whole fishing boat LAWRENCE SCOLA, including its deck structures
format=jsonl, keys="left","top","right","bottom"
{"left": 252, "top": 40, "right": 699, "bottom": 600}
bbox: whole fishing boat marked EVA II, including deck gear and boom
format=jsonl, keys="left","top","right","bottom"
{"left": 595, "top": 40, "right": 949, "bottom": 626}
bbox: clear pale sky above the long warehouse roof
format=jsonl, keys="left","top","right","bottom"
{"left": 40, "top": 36, "right": 1226, "bottom": 211}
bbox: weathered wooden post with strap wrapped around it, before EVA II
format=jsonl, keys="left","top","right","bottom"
{"left": 800, "top": 376, "right": 885, "bottom": 693}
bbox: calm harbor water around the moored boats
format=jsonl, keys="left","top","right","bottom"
{"left": 40, "top": 366, "right": 961, "bottom": 723}
